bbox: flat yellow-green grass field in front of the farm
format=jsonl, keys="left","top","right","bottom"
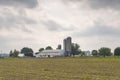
{"left": 0, "top": 57, "right": 120, "bottom": 80}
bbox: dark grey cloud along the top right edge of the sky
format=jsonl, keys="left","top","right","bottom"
{"left": 63, "top": 0, "right": 120, "bottom": 9}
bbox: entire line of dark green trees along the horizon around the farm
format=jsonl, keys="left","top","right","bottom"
{"left": 10, "top": 43, "right": 120, "bottom": 57}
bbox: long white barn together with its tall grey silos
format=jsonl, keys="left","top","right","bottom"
{"left": 35, "top": 37, "right": 72, "bottom": 58}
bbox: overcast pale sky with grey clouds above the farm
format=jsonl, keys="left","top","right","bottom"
{"left": 0, "top": 0, "right": 120, "bottom": 53}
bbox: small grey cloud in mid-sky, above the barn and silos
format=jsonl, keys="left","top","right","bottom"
{"left": 42, "top": 20, "right": 73, "bottom": 31}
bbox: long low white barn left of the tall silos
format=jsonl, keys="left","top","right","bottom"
{"left": 35, "top": 50, "right": 64, "bottom": 58}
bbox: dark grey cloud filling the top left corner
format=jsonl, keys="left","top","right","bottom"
{"left": 0, "top": 0, "right": 38, "bottom": 8}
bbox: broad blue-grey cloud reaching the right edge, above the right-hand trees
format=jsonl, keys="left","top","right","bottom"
{"left": 73, "top": 22, "right": 120, "bottom": 37}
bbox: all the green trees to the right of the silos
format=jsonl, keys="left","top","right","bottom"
{"left": 71, "top": 43, "right": 120, "bottom": 57}
